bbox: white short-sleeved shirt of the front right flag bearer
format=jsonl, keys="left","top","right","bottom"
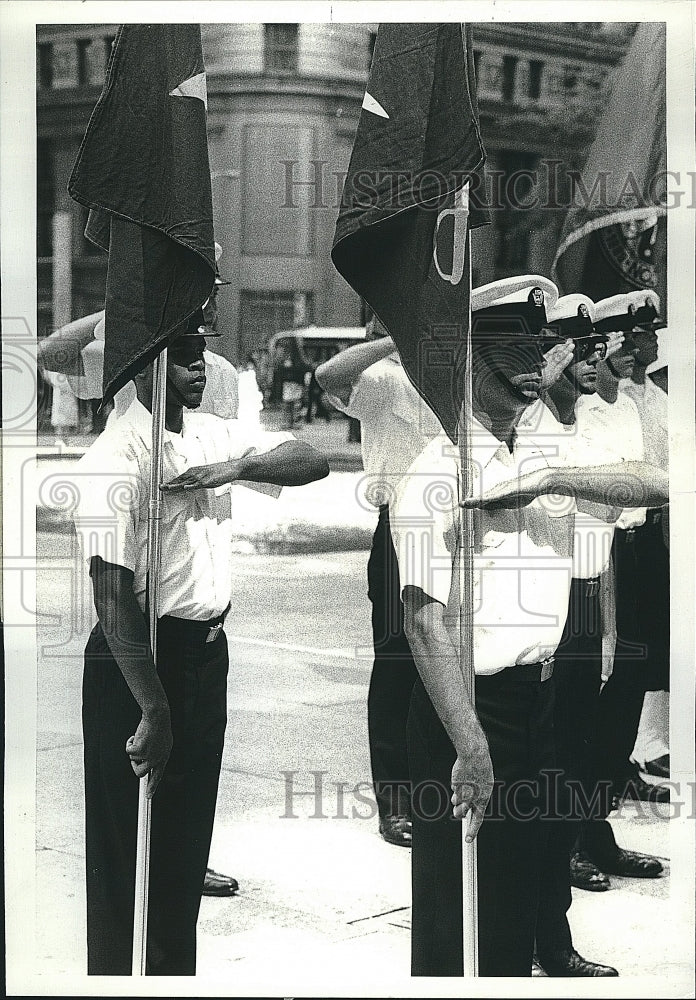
{"left": 390, "top": 420, "right": 575, "bottom": 674}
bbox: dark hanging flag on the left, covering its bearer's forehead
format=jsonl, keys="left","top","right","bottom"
{"left": 68, "top": 24, "right": 215, "bottom": 400}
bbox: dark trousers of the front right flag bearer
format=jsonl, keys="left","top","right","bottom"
{"left": 408, "top": 667, "right": 554, "bottom": 976}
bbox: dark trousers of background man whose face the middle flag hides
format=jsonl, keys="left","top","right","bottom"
{"left": 367, "top": 506, "right": 418, "bottom": 818}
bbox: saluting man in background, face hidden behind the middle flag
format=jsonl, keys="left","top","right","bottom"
{"left": 315, "top": 317, "right": 442, "bottom": 847}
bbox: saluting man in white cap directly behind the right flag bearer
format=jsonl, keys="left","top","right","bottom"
{"left": 530, "top": 295, "right": 662, "bottom": 976}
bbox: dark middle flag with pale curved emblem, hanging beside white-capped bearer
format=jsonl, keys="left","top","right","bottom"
{"left": 331, "top": 24, "right": 487, "bottom": 441}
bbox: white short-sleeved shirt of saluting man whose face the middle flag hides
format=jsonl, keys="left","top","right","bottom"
{"left": 329, "top": 357, "right": 442, "bottom": 507}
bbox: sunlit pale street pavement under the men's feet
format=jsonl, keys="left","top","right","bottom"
{"left": 29, "top": 528, "right": 693, "bottom": 997}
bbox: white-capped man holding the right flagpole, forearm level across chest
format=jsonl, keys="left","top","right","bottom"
{"left": 392, "top": 276, "right": 664, "bottom": 976}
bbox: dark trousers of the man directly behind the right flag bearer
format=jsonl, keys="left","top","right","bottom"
{"left": 536, "top": 580, "right": 602, "bottom": 958}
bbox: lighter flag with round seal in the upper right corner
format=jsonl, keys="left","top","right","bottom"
{"left": 553, "top": 22, "right": 667, "bottom": 311}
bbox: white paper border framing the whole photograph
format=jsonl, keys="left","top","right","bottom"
{"left": 0, "top": 0, "right": 696, "bottom": 997}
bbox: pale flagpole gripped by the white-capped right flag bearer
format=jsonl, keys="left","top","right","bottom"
{"left": 458, "top": 183, "right": 478, "bottom": 979}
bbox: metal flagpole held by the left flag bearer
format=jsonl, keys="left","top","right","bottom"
{"left": 132, "top": 347, "right": 167, "bottom": 976}
